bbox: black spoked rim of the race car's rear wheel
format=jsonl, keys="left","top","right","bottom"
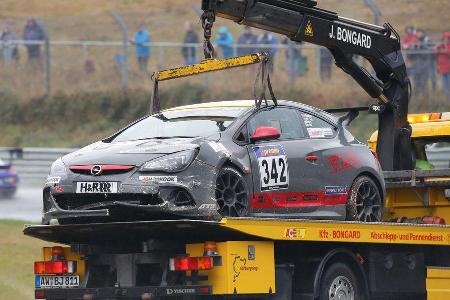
{"left": 356, "top": 181, "right": 382, "bottom": 222}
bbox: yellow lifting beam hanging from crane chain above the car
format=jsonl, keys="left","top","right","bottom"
{"left": 153, "top": 53, "right": 266, "bottom": 81}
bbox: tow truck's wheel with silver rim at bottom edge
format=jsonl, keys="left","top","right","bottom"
{"left": 319, "top": 262, "right": 364, "bottom": 300}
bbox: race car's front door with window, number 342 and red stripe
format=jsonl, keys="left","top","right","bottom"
{"left": 247, "top": 107, "right": 316, "bottom": 214}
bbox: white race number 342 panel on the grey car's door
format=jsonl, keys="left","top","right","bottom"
{"left": 254, "top": 145, "right": 289, "bottom": 191}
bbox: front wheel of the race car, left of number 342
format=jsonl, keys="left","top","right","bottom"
{"left": 215, "top": 167, "right": 250, "bottom": 217}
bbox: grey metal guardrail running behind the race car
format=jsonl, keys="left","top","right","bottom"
{"left": 0, "top": 147, "right": 450, "bottom": 182}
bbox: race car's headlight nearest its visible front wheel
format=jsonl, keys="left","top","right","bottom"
{"left": 141, "top": 149, "right": 198, "bottom": 173}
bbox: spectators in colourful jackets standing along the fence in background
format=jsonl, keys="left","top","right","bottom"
{"left": 0, "top": 18, "right": 450, "bottom": 98}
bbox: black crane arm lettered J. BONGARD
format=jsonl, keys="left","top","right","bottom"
{"left": 202, "top": 0, "right": 414, "bottom": 171}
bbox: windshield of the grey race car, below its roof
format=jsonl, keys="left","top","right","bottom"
{"left": 114, "top": 108, "right": 246, "bottom": 142}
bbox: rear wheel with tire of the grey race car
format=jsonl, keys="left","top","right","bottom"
{"left": 347, "top": 176, "right": 384, "bottom": 222}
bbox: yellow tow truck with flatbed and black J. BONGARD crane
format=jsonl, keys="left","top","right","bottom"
{"left": 24, "top": 0, "right": 450, "bottom": 300}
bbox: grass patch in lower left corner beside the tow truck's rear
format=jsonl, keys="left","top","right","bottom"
{"left": 0, "top": 220, "right": 49, "bottom": 300}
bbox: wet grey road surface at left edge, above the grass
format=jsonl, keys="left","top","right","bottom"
{"left": 0, "top": 185, "right": 42, "bottom": 222}
